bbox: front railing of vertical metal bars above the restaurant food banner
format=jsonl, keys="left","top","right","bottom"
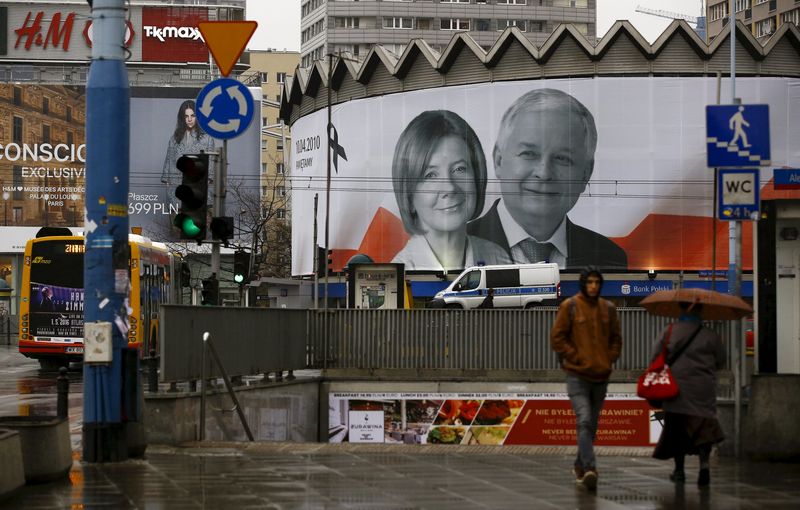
{"left": 309, "top": 308, "right": 732, "bottom": 370}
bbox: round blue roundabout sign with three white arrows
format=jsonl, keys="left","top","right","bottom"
{"left": 196, "top": 78, "right": 255, "bottom": 140}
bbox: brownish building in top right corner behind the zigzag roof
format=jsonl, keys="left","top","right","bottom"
{"left": 706, "top": 0, "right": 800, "bottom": 43}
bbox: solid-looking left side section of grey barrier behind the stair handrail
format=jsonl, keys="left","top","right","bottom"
{"left": 159, "top": 305, "right": 308, "bottom": 382}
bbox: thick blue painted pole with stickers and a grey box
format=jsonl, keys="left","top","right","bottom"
{"left": 83, "top": 0, "right": 130, "bottom": 462}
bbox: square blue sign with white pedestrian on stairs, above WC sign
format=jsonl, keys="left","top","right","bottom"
{"left": 706, "top": 104, "right": 771, "bottom": 168}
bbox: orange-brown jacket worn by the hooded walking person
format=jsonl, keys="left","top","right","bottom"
{"left": 550, "top": 293, "right": 622, "bottom": 381}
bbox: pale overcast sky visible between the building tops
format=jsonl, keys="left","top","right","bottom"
{"left": 247, "top": 0, "right": 702, "bottom": 51}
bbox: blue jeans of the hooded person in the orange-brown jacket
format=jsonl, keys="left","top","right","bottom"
{"left": 567, "top": 374, "right": 608, "bottom": 469}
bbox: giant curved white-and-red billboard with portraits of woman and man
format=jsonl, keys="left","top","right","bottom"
{"left": 292, "top": 77, "right": 800, "bottom": 274}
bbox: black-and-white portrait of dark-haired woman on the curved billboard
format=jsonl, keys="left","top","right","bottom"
{"left": 392, "top": 110, "right": 510, "bottom": 271}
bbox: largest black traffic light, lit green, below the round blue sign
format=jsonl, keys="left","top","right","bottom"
{"left": 174, "top": 154, "right": 209, "bottom": 243}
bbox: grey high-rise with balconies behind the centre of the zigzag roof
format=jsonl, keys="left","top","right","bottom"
{"left": 300, "top": 0, "right": 597, "bottom": 67}
